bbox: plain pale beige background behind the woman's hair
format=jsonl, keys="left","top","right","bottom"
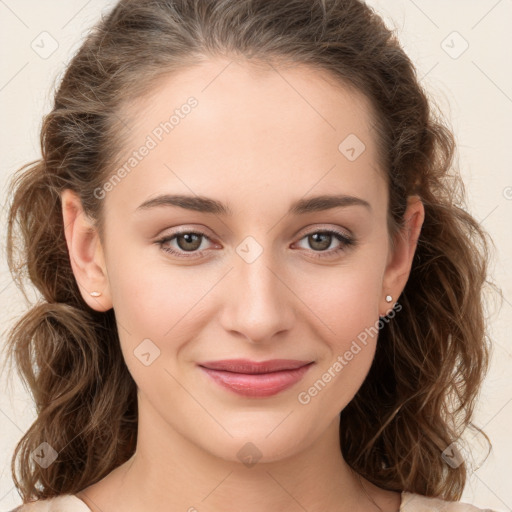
{"left": 0, "top": 0, "right": 512, "bottom": 511}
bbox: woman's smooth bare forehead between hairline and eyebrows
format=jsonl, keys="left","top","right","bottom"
{"left": 106, "top": 59, "right": 383, "bottom": 215}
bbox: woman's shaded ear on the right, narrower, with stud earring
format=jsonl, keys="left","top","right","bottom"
{"left": 381, "top": 196, "right": 425, "bottom": 316}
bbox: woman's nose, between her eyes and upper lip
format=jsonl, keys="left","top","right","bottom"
{"left": 220, "top": 243, "right": 298, "bottom": 344}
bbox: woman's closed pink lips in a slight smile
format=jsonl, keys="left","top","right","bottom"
{"left": 199, "top": 359, "right": 314, "bottom": 398}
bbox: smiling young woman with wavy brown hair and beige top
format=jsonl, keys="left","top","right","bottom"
{"left": 3, "top": 0, "right": 500, "bottom": 512}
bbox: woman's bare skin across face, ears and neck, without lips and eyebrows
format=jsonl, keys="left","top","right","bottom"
{"left": 62, "top": 59, "right": 424, "bottom": 512}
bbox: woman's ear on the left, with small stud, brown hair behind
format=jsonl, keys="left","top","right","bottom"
{"left": 61, "top": 189, "right": 112, "bottom": 311}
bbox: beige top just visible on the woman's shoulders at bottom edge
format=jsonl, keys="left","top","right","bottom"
{"left": 11, "top": 491, "right": 497, "bottom": 512}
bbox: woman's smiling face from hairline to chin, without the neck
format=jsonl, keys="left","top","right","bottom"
{"left": 65, "top": 60, "right": 420, "bottom": 461}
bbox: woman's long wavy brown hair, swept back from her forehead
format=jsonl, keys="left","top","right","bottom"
{"left": 1, "top": 0, "right": 491, "bottom": 502}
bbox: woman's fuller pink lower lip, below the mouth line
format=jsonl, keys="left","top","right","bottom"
{"left": 200, "top": 363, "right": 313, "bottom": 397}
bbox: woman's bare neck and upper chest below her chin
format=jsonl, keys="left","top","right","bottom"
{"left": 77, "top": 400, "right": 400, "bottom": 512}
